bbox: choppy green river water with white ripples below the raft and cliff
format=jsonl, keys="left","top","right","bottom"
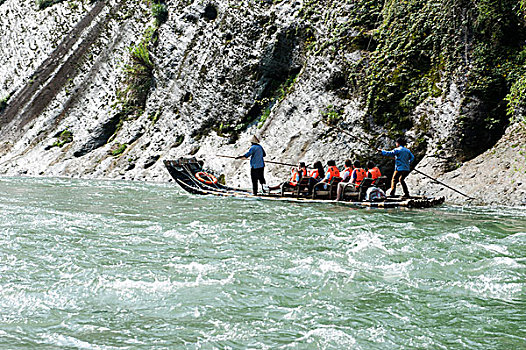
{"left": 0, "top": 178, "right": 526, "bottom": 349}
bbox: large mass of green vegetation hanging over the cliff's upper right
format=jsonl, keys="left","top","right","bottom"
{"left": 302, "top": 0, "right": 526, "bottom": 148}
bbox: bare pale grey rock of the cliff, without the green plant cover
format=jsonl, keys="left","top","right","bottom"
{"left": 0, "top": 0, "right": 524, "bottom": 203}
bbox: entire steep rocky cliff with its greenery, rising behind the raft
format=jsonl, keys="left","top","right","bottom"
{"left": 0, "top": 0, "right": 526, "bottom": 205}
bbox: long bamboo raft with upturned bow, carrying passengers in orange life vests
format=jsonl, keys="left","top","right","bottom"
{"left": 164, "top": 158, "right": 444, "bottom": 208}
